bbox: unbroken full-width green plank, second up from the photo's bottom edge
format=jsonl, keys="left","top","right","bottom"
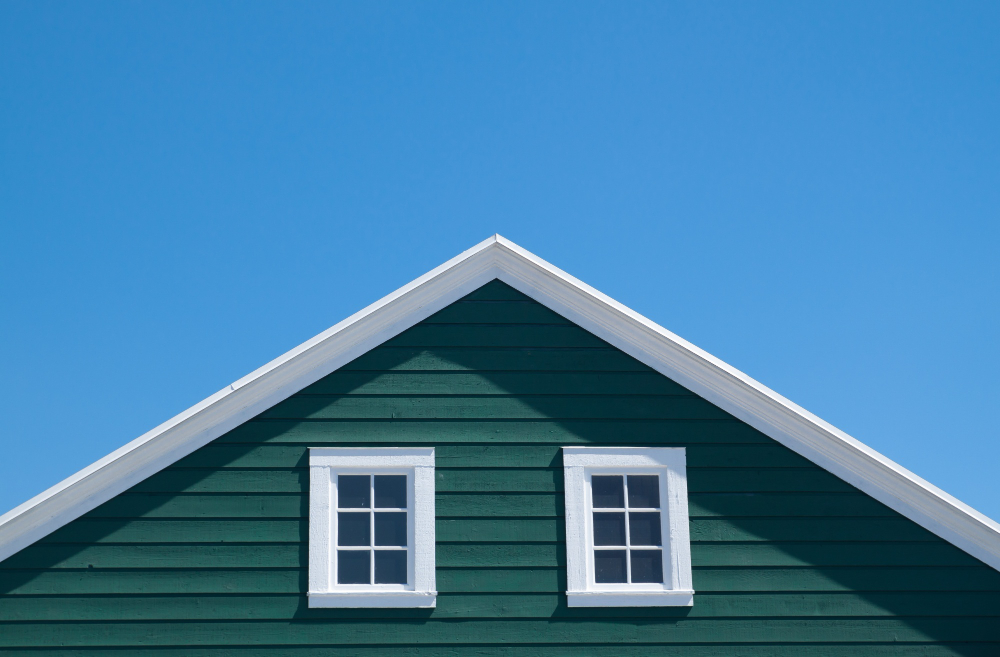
{"left": 0, "top": 618, "right": 1000, "bottom": 647}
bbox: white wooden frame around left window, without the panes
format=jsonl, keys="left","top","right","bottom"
{"left": 308, "top": 447, "right": 437, "bottom": 607}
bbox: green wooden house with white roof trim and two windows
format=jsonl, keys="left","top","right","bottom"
{"left": 0, "top": 236, "right": 1000, "bottom": 657}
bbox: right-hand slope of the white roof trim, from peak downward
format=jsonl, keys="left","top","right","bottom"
{"left": 488, "top": 238, "right": 1000, "bottom": 570}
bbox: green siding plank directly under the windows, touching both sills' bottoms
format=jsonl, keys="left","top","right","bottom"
{"left": 0, "top": 592, "right": 1000, "bottom": 622}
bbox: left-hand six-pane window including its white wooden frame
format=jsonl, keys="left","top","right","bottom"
{"left": 309, "top": 447, "right": 437, "bottom": 607}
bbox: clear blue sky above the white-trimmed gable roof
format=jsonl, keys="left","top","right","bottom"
{"left": 0, "top": 0, "right": 1000, "bottom": 519}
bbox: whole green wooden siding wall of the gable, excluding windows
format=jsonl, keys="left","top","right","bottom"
{"left": 0, "top": 282, "right": 1000, "bottom": 657}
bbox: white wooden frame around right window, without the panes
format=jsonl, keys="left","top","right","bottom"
{"left": 563, "top": 447, "right": 694, "bottom": 607}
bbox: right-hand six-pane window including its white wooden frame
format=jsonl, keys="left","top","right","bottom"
{"left": 563, "top": 447, "right": 694, "bottom": 607}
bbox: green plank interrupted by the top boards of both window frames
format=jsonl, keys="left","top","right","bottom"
{"left": 174, "top": 443, "right": 816, "bottom": 468}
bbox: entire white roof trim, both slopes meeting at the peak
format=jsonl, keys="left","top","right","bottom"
{"left": 0, "top": 235, "right": 1000, "bottom": 570}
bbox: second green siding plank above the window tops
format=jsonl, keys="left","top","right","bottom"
{"left": 258, "top": 395, "right": 731, "bottom": 420}
